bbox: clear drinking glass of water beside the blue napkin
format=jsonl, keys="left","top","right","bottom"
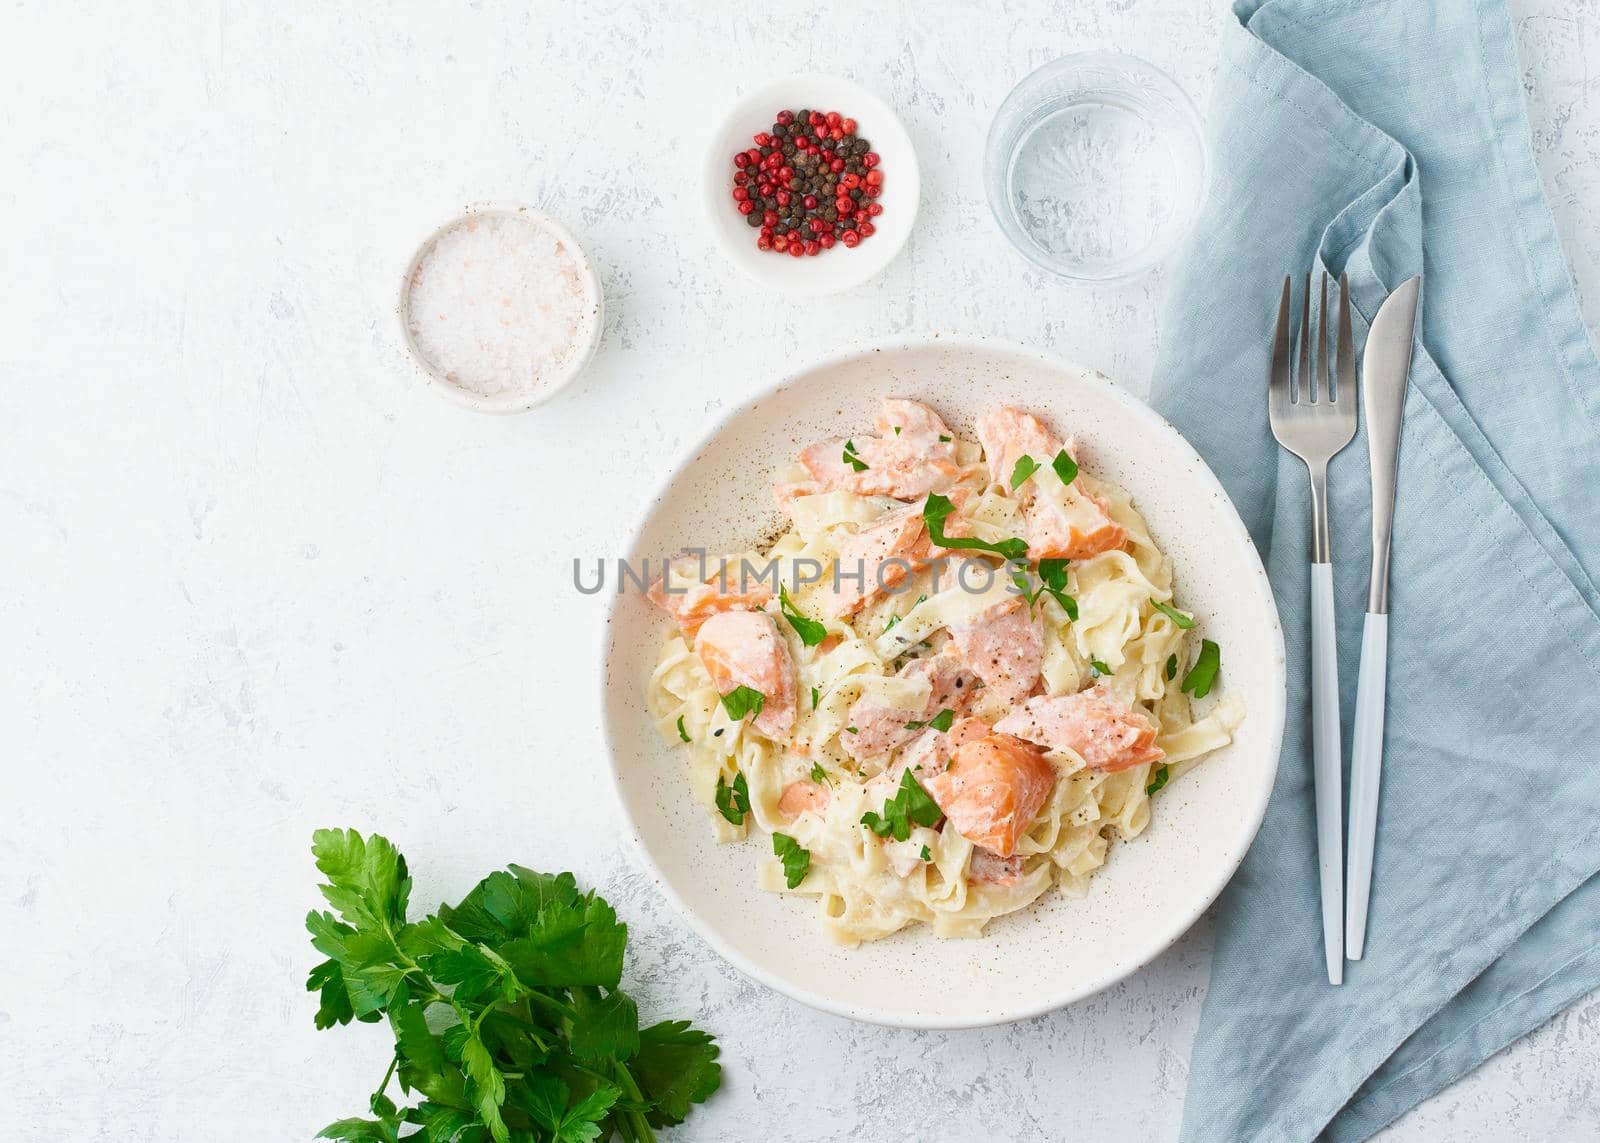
{"left": 984, "top": 51, "right": 1210, "bottom": 282}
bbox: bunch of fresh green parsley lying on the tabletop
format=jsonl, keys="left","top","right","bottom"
{"left": 306, "top": 829, "right": 722, "bottom": 1143}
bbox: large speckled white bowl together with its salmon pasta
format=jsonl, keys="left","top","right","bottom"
{"left": 606, "top": 344, "right": 1283, "bottom": 1026}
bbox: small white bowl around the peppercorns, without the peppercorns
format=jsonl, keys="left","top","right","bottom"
{"left": 701, "top": 75, "right": 922, "bottom": 298}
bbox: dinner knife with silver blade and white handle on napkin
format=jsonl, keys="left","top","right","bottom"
{"left": 1344, "top": 275, "right": 1422, "bottom": 961}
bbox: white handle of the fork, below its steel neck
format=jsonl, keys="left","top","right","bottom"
{"left": 1310, "top": 562, "right": 1344, "bottom": 985}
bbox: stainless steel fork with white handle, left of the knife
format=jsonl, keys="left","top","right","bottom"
{"left": 1267, "top": 272, "right": 1355, "bottom": 985}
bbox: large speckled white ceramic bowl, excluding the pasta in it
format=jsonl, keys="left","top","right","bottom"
{"left": 602, "top": 341, "right": 1285, "bottom": 1028}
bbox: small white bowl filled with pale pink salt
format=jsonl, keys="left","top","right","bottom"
{"left": 398, "top": 203, "right": 605, "bottom": 413}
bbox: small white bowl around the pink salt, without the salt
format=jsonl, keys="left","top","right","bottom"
{"left": 397, "top": 202, "right": 605, "bottom": 413}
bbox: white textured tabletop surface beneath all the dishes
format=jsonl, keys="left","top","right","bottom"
{"left": 0, "top": 0, "right": 1600, "bottom": 1141}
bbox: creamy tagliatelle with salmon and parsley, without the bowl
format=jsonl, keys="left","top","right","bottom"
{"left": 648, "top": 402, "right": 1245, "bottom": 944}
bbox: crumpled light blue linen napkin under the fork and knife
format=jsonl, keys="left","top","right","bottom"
{"left": 1155, "top": 0, "right": 1600, "bottom": 1141}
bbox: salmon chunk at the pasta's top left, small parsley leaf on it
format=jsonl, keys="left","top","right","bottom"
{"left": 800, "top": 397, "right": 960, "bottom": 499}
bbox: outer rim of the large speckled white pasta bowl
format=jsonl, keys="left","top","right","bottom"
{"left": 597, "top": 336, "right": 1288, "bottom": 1031}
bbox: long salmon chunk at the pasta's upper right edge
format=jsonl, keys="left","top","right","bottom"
{"left": 978, "top": 405, "right": 1128, "bottom": 560}
